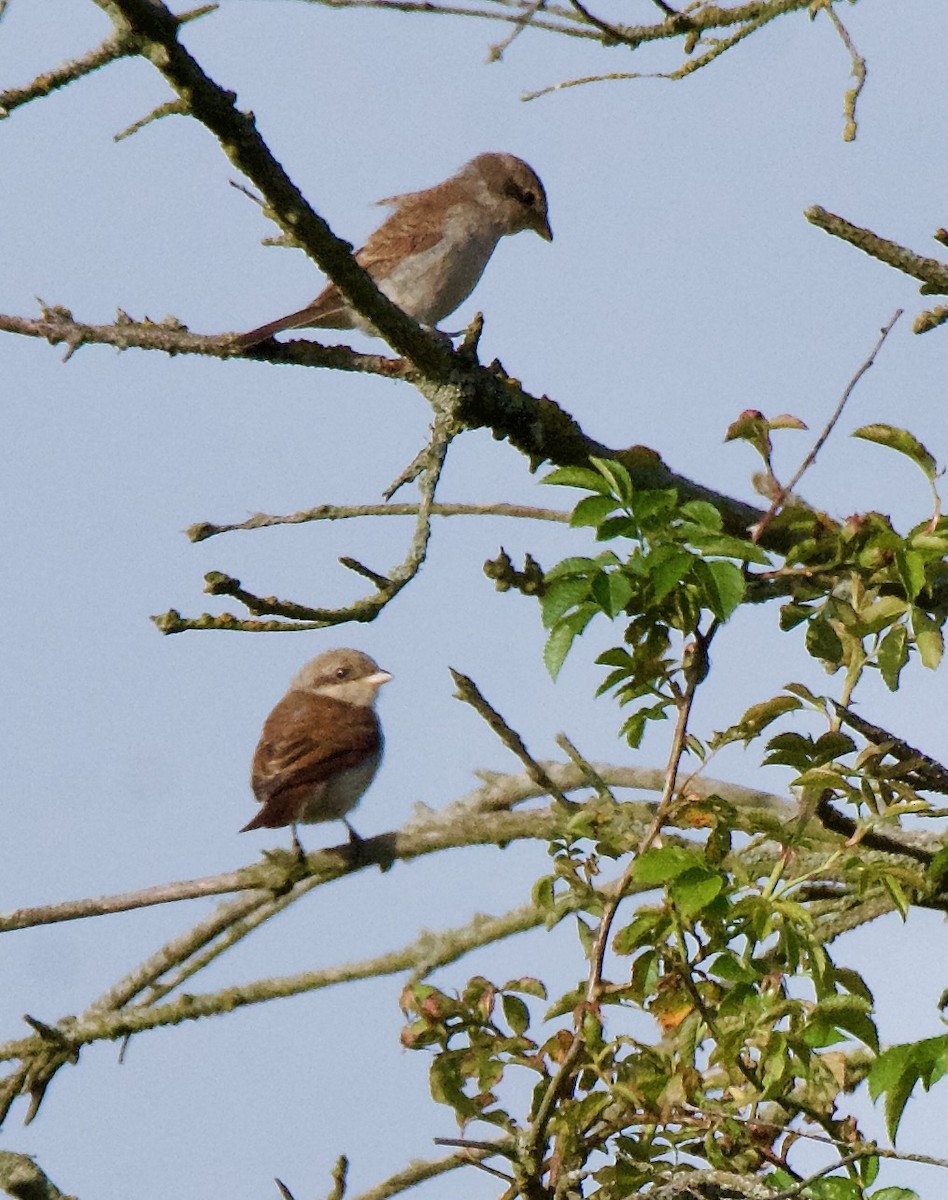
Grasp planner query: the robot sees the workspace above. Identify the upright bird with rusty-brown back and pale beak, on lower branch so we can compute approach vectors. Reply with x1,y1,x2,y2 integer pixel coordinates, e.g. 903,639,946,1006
240,649,392,857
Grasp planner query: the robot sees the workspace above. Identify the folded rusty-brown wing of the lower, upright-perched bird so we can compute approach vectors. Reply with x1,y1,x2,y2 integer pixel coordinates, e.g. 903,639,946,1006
246,691,382,829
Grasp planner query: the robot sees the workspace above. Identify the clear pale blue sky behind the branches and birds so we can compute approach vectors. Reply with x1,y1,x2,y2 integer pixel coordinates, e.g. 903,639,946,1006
0,0,948,1200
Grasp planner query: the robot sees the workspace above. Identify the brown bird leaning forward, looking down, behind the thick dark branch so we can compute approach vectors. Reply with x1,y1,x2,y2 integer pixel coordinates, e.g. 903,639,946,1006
236,154,553,349
